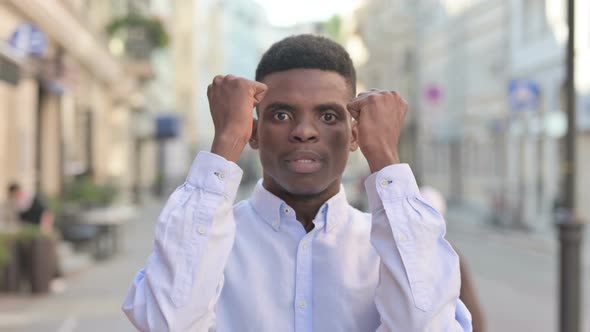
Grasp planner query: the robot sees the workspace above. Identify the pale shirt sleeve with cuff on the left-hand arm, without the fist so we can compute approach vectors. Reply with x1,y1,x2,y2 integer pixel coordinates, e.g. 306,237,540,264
123,152,242,332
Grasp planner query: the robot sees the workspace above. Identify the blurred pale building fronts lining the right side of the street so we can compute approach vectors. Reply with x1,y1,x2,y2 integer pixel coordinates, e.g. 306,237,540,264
358,0,590,231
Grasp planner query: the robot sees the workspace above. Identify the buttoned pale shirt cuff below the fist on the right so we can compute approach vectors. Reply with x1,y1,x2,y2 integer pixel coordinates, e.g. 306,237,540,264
365,164,420,211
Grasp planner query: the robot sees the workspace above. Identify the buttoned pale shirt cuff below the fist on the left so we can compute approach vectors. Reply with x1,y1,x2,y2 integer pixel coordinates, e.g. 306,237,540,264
186,151,244,201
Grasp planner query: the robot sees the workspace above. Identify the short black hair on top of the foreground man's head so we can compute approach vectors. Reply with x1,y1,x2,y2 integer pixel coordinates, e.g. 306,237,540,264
256,34,356,95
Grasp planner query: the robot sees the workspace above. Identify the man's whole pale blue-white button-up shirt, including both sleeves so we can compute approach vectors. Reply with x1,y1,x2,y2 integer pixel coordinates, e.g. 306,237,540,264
123,152,471,332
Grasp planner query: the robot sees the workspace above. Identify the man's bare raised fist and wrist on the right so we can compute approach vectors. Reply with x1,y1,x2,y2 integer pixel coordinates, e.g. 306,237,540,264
347,89,408,173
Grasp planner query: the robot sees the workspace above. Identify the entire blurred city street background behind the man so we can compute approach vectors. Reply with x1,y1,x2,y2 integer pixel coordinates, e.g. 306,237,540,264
0,0,590,332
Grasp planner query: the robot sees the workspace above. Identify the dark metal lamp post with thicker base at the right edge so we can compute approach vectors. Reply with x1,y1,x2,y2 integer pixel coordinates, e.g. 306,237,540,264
555,0,583,332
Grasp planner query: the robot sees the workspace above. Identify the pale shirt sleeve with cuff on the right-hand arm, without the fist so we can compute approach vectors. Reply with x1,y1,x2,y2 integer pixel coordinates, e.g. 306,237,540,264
365,164,471,332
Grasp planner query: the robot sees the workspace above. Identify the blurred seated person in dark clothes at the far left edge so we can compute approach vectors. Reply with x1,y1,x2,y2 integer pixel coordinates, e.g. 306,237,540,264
8,183,53,234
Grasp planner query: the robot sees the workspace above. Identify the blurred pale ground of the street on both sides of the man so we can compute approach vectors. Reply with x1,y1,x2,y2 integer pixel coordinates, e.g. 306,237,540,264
0,195,590,332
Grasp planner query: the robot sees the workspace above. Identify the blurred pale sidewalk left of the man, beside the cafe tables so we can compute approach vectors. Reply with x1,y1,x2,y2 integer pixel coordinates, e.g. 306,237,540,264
0,200,164,332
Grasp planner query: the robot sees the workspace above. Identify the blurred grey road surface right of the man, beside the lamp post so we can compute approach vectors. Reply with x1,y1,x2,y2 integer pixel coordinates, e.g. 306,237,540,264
447,207,590,332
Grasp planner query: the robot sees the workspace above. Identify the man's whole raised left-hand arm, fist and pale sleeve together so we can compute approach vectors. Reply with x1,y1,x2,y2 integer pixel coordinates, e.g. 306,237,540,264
123,75,266,332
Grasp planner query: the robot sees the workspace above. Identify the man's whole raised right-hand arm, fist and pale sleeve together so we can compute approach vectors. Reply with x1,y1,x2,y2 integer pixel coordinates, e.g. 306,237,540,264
347,90,471,332
